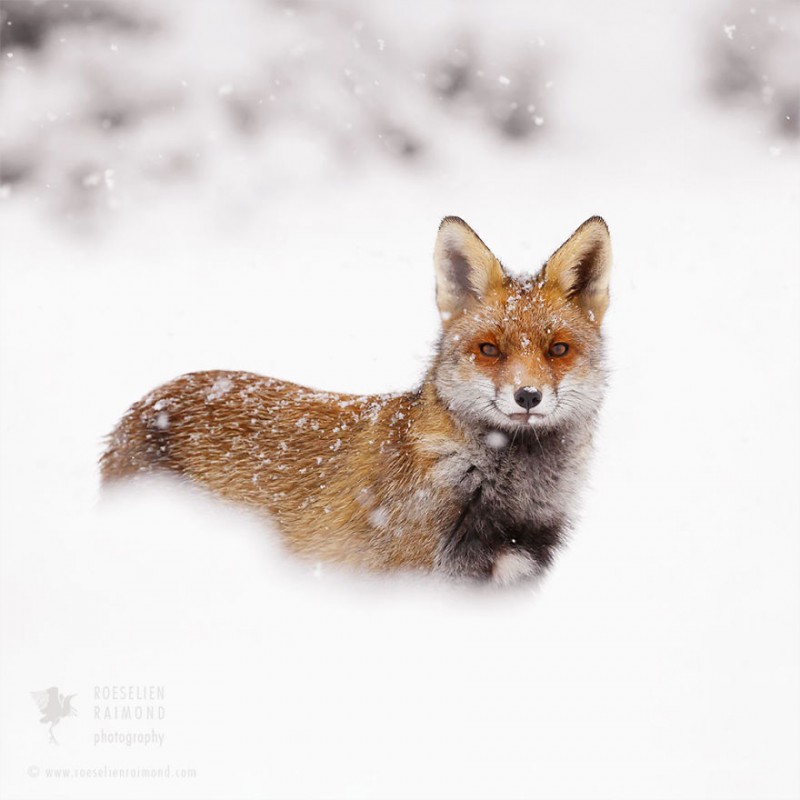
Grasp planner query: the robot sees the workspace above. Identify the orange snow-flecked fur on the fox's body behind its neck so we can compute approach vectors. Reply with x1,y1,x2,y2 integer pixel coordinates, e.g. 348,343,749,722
102,371,457,569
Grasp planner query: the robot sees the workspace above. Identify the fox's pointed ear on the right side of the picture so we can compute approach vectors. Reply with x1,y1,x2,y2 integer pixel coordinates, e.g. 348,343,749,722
544,217,611,324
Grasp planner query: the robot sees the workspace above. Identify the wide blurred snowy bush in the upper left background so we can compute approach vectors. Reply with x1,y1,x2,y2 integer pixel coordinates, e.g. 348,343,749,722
0,0,545,212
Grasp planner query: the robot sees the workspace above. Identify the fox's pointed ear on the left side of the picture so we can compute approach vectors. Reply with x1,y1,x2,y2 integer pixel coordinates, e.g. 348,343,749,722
433,217,505,321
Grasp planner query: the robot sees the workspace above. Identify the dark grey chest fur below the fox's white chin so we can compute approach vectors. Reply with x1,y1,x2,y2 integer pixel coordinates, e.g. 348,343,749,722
439,429,590,580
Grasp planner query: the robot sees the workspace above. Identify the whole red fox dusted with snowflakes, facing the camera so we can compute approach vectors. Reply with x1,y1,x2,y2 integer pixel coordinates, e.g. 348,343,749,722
101,217,611,585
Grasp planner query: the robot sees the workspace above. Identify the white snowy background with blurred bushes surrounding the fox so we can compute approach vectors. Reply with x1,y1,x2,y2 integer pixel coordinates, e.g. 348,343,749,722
0,0,800,800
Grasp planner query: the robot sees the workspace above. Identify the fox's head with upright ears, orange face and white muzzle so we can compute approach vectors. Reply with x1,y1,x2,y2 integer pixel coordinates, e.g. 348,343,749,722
434,217,611,432
